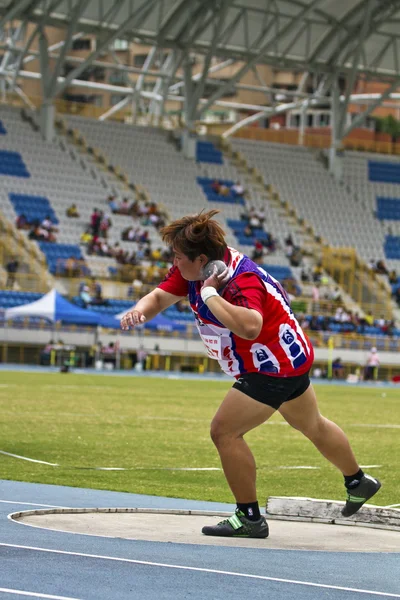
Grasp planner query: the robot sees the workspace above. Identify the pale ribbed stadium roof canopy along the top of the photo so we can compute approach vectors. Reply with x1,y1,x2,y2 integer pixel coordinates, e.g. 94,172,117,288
0,0,400,78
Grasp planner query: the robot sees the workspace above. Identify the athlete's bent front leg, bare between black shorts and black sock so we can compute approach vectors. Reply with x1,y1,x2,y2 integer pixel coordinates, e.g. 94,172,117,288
211,388,275,504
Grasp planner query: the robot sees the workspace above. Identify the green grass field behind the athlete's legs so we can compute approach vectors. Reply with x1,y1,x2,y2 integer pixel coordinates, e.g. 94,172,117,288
0,372,400,506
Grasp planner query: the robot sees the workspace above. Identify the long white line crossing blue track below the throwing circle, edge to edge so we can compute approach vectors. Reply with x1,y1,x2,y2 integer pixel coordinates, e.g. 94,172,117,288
0,542,400,598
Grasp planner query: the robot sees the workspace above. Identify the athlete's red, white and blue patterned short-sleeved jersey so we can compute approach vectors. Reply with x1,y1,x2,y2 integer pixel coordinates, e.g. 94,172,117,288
159,248,314,378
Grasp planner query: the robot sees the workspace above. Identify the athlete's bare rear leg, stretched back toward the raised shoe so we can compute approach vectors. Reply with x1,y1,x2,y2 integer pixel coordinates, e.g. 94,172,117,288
279,385,360,475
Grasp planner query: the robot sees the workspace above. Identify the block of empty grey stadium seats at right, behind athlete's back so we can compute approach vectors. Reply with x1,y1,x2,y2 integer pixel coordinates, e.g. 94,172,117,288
232,139,396,268
